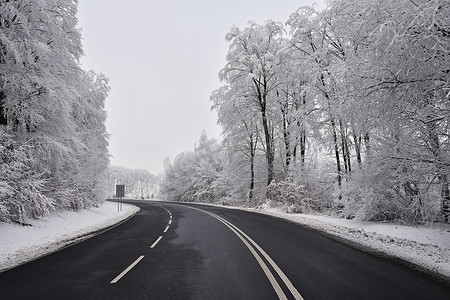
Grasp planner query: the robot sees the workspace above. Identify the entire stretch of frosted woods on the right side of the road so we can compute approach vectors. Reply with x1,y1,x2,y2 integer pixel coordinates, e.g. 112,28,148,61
162,0,450,223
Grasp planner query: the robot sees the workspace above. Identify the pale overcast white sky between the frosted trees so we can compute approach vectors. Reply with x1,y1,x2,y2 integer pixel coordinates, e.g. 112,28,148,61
78,0,324,174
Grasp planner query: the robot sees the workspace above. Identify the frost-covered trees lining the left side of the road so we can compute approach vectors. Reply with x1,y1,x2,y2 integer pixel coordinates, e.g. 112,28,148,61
0,0,109,224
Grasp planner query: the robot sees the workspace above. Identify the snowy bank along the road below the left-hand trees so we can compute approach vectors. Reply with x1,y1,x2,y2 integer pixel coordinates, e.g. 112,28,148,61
0,202,139,272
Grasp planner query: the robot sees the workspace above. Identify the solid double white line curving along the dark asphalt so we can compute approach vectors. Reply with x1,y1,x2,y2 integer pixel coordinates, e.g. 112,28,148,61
190,206,303,300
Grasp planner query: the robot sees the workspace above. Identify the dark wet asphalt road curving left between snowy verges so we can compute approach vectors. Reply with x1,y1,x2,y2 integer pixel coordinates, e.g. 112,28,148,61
0,201,450,300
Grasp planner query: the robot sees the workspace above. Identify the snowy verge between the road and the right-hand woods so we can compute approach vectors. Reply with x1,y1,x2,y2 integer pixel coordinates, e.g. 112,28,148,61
245,205,450,280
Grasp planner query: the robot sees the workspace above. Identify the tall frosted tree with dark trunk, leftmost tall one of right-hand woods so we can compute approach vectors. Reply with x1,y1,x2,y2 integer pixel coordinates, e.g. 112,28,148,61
220,21,284,185
